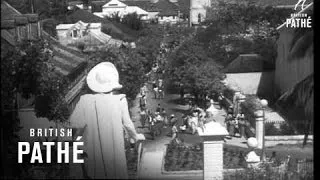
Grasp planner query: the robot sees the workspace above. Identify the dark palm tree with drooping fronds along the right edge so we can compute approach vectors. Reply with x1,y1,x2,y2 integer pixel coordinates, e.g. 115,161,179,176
278,7,314,146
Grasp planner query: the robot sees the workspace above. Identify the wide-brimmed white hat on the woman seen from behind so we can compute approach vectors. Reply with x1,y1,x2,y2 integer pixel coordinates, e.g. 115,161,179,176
87,62,122,93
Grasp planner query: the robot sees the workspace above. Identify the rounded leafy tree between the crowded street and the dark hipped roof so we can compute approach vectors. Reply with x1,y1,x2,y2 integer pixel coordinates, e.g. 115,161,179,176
167,41,224,98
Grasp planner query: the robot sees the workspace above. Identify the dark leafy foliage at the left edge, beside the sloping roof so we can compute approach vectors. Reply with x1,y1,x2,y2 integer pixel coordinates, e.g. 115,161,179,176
1,40,68,121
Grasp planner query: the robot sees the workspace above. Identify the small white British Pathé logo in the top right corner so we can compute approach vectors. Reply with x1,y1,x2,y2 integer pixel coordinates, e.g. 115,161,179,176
286,0,311,28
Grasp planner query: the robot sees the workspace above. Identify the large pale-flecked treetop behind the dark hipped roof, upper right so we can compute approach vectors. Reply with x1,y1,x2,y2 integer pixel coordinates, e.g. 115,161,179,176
202,2,292,68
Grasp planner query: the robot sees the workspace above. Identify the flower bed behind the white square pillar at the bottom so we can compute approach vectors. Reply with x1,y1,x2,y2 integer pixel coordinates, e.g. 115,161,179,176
164,144,247,171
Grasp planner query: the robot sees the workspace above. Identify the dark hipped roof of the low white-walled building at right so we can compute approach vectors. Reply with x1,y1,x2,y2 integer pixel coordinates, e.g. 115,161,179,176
223,54,269,73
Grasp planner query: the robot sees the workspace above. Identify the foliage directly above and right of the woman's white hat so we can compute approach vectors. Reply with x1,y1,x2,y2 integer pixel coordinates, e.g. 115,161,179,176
90,48,147,101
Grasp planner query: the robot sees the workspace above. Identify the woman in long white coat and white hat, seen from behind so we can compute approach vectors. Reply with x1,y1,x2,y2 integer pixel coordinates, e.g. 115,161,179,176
70,62,145,179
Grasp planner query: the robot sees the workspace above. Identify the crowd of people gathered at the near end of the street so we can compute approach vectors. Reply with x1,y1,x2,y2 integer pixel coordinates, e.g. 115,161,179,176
140,76,254,142
